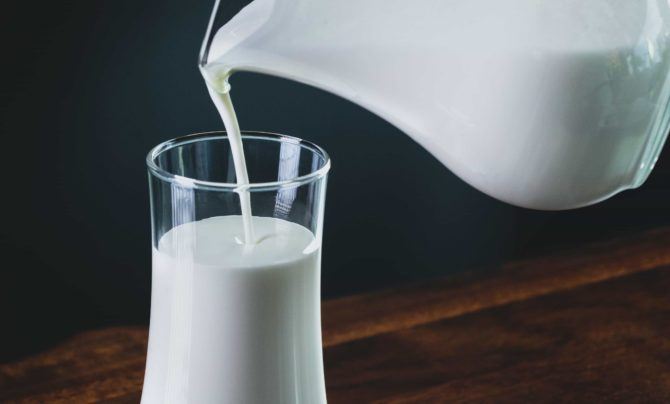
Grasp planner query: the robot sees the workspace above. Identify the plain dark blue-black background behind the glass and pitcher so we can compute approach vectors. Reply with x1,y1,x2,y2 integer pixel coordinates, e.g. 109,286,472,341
0,0,670,360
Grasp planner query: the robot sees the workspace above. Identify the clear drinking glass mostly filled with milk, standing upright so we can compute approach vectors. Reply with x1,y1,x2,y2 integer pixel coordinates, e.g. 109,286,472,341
142,132,330,403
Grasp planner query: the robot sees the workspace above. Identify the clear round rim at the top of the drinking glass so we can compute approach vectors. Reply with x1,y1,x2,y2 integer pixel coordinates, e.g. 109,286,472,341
146,130,330,192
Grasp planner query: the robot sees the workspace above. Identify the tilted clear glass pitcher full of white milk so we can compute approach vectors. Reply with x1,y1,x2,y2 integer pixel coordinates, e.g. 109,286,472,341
204,0,670,209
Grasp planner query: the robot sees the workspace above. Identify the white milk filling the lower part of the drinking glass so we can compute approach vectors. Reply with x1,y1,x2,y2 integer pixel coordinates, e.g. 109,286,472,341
142,216,326,404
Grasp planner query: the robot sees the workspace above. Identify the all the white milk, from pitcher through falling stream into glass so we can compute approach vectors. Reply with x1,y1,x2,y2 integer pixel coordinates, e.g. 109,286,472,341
142,0,670,403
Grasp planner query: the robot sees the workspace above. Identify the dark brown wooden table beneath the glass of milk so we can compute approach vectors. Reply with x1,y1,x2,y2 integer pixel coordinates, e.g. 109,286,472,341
0,229,670,403
